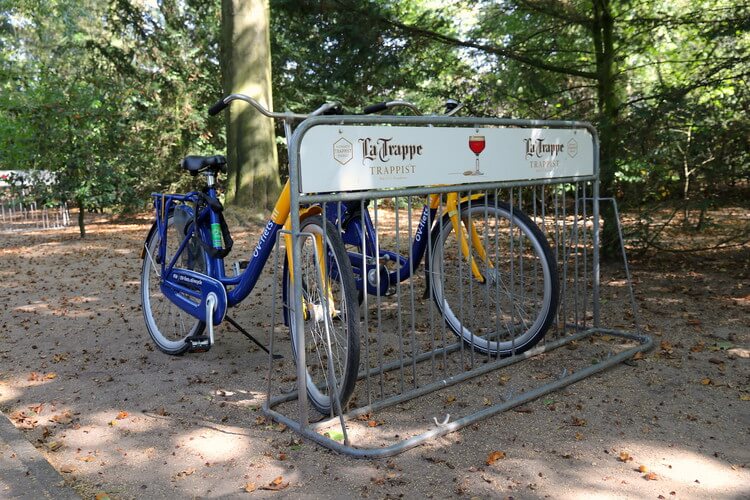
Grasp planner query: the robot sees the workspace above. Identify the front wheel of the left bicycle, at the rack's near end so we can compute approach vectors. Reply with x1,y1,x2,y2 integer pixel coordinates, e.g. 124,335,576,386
284,216,359,415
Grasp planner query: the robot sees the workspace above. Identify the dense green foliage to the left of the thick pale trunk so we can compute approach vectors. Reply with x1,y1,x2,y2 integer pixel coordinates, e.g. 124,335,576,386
0,0,223,233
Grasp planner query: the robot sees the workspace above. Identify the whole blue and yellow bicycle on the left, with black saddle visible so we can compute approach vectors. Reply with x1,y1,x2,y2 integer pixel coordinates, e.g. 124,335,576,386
141,94,359,415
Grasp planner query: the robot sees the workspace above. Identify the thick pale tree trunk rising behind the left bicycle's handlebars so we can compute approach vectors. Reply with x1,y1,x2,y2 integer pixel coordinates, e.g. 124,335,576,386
221,0,281,209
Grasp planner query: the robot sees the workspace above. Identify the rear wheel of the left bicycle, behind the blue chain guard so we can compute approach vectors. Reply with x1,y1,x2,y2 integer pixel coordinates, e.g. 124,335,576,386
141,215,206,355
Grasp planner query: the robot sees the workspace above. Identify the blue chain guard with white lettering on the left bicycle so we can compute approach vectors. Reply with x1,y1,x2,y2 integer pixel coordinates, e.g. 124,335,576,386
160,269,227,325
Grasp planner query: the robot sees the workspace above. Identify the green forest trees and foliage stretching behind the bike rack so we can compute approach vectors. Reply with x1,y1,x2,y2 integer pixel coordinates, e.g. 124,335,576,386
0,0,750,248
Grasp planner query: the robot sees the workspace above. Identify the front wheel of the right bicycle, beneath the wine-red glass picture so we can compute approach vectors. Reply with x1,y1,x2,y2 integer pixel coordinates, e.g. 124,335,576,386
430,199,559,356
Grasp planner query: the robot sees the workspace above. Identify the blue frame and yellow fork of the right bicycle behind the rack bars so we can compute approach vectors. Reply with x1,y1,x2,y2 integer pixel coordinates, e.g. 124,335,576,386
326,192,494,295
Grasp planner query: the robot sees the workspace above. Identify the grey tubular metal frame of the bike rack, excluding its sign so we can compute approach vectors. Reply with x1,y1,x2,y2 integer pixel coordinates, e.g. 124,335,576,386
263,116,653,458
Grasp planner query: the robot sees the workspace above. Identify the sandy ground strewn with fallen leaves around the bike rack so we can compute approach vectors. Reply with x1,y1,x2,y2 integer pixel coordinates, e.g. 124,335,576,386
0,210,750,498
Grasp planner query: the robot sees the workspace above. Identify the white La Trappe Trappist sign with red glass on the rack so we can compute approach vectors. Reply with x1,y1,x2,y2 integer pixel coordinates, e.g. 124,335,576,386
300,125,594,193
